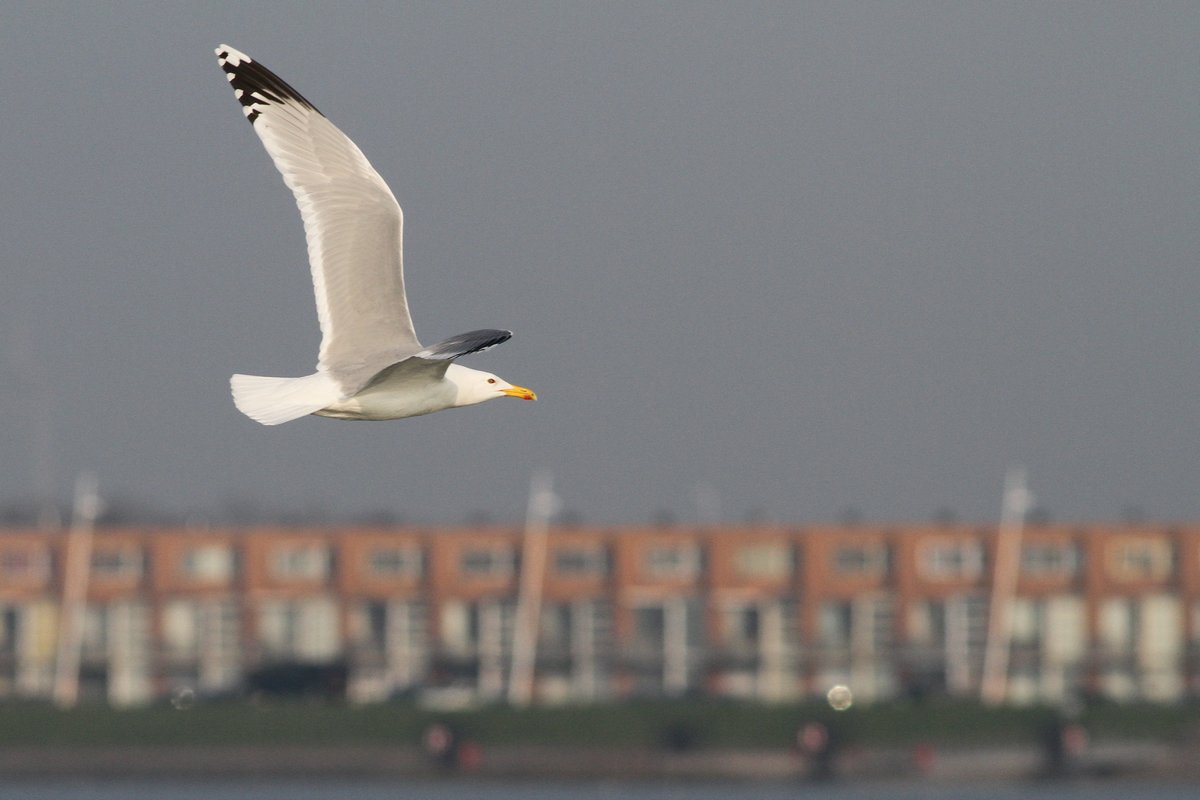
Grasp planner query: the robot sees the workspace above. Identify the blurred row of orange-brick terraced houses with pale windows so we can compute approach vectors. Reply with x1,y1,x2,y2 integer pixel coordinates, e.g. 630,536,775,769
0,523,1200,705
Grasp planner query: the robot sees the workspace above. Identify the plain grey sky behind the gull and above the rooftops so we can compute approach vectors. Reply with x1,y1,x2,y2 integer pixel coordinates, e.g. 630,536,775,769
0,1,1200,522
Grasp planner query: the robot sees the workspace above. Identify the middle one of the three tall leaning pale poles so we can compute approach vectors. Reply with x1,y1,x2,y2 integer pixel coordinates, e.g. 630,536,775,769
509,473,558,706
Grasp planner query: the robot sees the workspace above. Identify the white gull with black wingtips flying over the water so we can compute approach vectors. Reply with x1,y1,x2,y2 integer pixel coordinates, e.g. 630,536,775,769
216,44,535,425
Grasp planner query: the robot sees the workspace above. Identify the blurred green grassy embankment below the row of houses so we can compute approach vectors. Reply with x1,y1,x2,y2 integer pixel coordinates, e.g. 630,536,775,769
0,700,1200,750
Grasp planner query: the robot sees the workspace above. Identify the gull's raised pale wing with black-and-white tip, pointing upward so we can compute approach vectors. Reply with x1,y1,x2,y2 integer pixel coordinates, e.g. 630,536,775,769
216,44,421,395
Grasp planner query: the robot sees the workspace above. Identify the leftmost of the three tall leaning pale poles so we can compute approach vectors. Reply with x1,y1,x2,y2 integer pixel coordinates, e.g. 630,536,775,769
54,473,101,708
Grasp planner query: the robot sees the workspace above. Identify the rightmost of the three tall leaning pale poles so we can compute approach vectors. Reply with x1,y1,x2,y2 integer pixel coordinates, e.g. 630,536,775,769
979,467,1033,705
